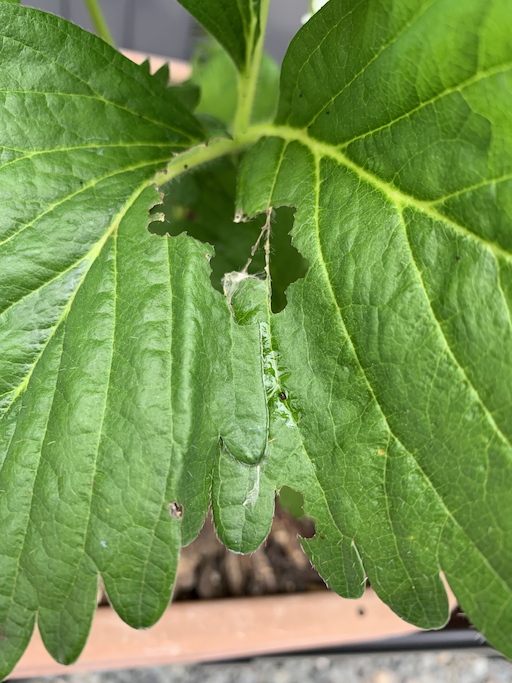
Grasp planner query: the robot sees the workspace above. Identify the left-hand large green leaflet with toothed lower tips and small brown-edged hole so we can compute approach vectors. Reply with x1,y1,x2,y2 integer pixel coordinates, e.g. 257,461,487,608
0,3,231,675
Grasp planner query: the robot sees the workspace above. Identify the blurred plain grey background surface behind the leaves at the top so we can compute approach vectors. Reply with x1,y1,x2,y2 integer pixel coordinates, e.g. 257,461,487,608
22,0,309,60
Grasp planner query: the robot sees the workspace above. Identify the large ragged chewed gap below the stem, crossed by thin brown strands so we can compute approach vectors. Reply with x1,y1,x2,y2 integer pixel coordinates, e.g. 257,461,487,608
149,159,308,313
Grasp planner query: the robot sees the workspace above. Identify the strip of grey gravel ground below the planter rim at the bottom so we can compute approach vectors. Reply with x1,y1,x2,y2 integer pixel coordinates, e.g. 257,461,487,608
15,651,512,683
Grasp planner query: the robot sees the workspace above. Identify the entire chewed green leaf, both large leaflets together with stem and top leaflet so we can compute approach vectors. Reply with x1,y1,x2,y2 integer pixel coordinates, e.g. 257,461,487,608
0,0,512,674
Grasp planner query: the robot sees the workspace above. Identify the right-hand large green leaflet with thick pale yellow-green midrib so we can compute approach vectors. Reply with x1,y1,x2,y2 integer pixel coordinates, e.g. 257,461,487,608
236,0,512,655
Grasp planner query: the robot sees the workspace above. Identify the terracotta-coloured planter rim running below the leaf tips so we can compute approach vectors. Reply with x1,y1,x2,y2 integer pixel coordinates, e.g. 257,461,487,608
10,590,453,678
